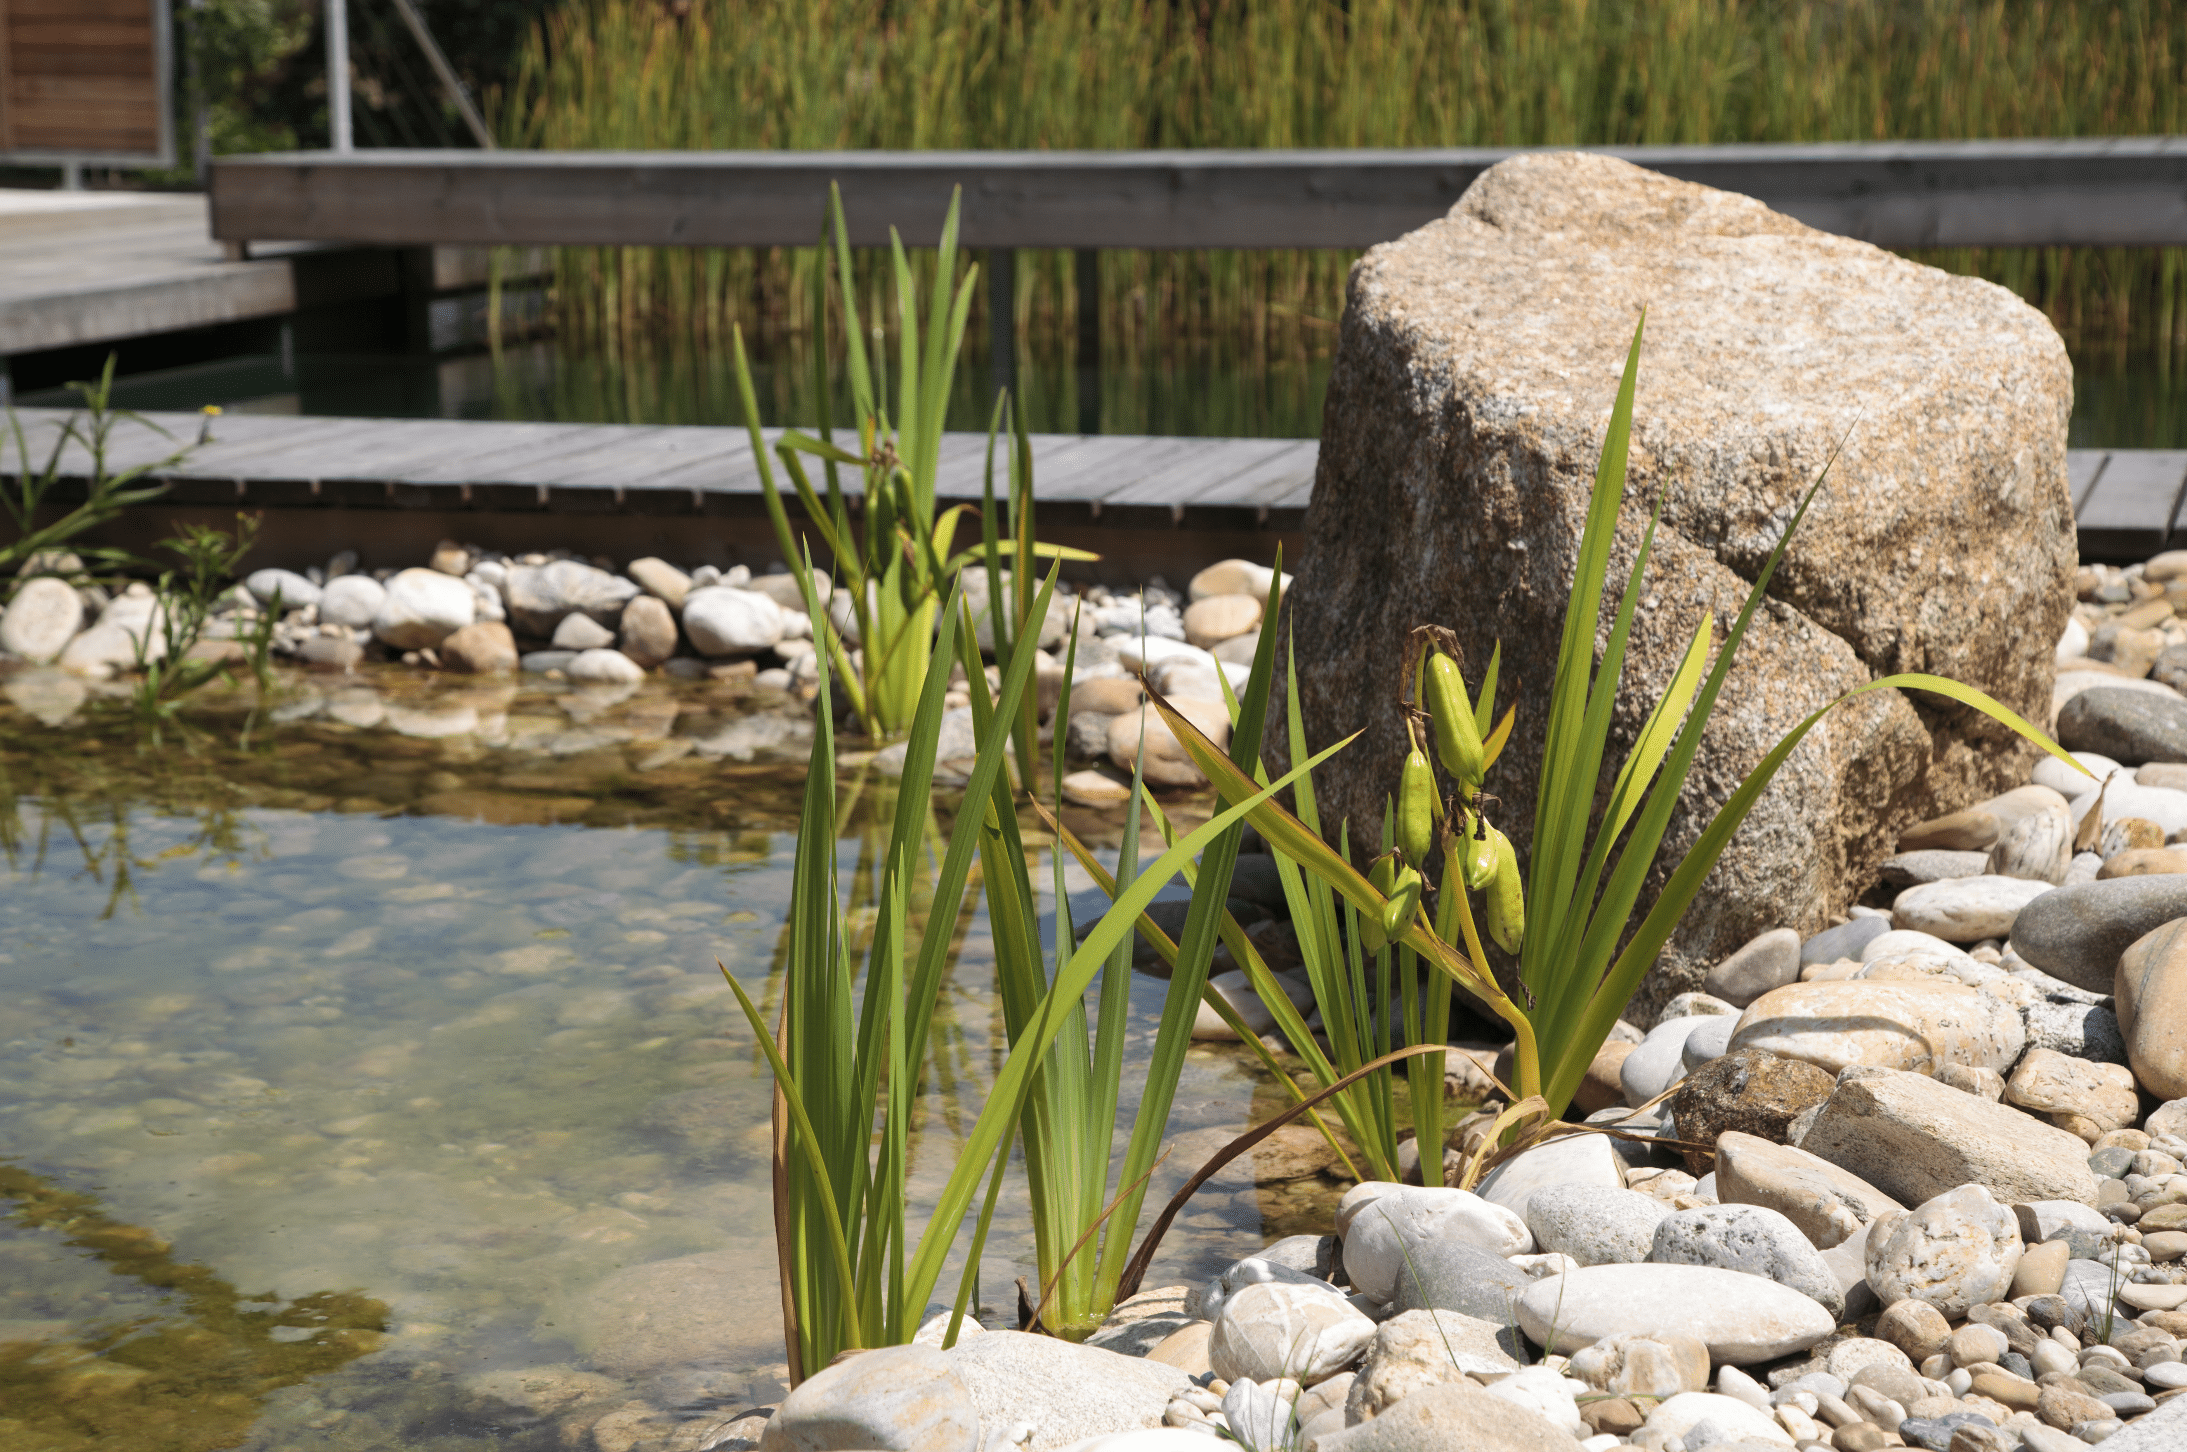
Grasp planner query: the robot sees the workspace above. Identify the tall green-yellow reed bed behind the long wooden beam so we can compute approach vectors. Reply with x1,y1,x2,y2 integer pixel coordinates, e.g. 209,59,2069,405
496,0,2187,407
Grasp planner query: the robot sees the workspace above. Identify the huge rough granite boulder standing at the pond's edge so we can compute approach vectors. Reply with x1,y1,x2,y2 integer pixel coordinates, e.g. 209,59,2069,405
1286,153,2075,1004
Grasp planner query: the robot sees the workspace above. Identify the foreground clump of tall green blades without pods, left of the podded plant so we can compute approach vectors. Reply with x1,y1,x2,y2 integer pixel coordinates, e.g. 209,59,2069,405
730,408,1325,1378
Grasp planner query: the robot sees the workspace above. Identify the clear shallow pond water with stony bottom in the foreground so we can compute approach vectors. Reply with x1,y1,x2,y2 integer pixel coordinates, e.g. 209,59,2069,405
0,667,1341,1452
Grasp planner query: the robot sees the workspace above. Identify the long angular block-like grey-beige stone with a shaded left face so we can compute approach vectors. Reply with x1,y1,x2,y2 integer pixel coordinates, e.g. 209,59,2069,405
1800,1069,2095,1205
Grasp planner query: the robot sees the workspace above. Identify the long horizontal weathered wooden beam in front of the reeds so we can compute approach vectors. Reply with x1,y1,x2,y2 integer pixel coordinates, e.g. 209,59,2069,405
212,138,2187,249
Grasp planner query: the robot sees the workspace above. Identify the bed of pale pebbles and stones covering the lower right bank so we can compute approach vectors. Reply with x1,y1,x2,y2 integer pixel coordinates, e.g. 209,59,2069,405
746,553,2187,1452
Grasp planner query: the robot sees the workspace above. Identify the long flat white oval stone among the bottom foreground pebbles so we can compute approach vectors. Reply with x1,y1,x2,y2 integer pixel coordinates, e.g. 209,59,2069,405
1518,1264,1837,1367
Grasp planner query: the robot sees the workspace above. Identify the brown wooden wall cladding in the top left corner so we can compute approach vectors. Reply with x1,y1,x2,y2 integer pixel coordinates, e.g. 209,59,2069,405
0,0,173,164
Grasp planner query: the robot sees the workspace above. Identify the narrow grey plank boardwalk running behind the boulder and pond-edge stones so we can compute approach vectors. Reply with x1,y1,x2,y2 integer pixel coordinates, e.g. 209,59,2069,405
0,409,2187,560
